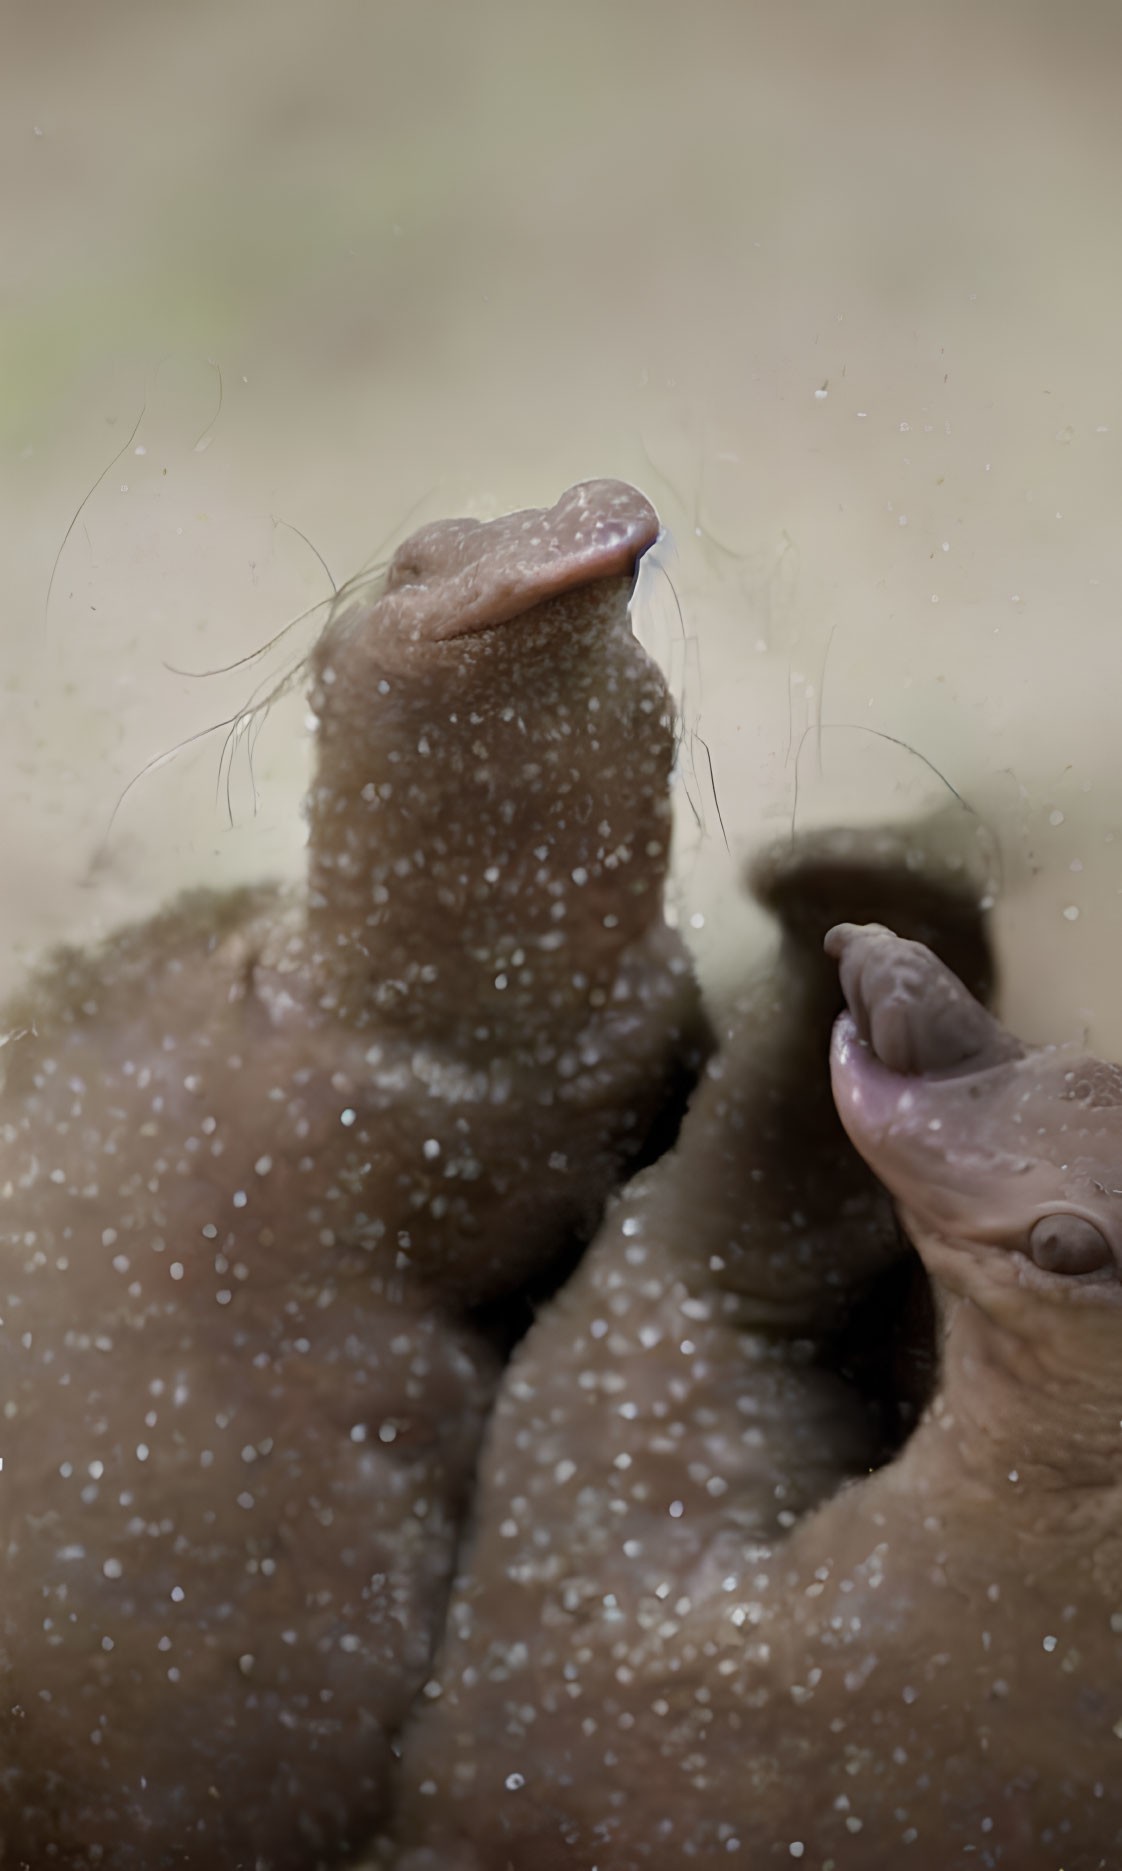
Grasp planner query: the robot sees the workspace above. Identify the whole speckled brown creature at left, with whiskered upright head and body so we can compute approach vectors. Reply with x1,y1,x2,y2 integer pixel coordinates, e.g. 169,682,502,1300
0,481,701,1871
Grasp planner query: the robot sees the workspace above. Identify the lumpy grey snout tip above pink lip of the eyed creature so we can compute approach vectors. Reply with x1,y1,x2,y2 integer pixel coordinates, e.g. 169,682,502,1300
825,922,1025,1141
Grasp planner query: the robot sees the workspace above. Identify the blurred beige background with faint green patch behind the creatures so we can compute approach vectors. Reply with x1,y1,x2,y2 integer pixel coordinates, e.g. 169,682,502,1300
0,0,1122,1053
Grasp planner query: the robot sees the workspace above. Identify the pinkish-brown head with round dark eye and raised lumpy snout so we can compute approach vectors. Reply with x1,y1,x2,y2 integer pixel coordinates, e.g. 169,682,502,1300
827,922,1122,1364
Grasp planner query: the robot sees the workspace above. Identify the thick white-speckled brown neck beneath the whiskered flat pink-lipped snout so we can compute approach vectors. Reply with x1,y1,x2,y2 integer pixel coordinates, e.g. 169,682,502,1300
309,632,673,1050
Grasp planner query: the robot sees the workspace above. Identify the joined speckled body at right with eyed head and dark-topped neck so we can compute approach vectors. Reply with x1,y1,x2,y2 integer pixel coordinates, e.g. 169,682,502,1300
389,812,1122,1871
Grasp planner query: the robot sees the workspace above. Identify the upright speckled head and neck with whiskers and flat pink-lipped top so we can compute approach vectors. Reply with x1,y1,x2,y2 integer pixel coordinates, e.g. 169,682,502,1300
307,481,675,1038
